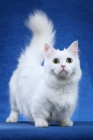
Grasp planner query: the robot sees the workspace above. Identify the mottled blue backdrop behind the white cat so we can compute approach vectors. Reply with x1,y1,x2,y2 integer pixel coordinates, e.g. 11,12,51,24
0,0,93,121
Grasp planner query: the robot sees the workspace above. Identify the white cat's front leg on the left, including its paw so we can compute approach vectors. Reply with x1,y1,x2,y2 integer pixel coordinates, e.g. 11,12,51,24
31,96,49,127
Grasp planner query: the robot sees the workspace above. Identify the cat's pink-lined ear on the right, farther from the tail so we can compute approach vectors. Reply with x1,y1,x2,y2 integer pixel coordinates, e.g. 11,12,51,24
68,41,79,56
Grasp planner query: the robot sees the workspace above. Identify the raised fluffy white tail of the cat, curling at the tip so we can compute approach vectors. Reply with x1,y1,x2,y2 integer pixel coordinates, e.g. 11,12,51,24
18,11,55,67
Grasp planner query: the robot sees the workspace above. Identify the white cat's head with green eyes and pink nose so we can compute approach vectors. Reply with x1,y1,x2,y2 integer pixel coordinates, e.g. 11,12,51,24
44,41,81,79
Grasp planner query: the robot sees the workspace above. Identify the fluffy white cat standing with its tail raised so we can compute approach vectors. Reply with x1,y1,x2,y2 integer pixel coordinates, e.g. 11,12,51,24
6,11,81,127
